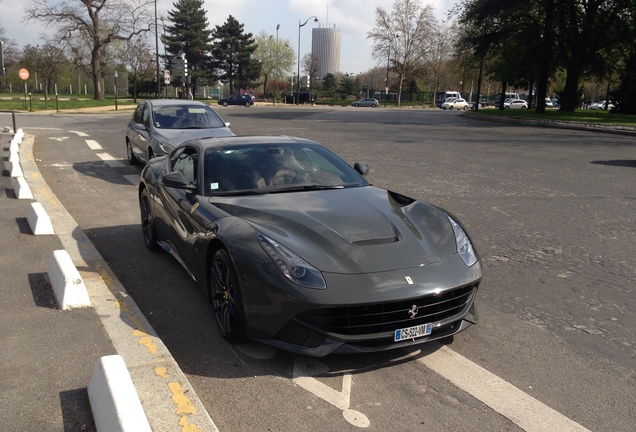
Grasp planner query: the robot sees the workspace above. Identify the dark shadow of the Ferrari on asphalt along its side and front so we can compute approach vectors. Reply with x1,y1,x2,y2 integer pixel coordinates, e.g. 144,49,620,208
85,225,452,379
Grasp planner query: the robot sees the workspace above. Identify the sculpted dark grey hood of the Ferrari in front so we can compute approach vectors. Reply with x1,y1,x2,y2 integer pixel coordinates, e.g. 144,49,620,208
211,186,457,274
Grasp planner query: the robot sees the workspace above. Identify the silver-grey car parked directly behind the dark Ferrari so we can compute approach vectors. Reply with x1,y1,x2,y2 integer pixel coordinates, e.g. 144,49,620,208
126,99,234,165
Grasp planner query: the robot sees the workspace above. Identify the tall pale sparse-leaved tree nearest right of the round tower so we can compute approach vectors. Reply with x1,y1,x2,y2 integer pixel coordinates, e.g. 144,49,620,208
367,0,436,106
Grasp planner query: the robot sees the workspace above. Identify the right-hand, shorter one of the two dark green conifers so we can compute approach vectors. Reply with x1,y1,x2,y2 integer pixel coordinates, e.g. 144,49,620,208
212,15,261,94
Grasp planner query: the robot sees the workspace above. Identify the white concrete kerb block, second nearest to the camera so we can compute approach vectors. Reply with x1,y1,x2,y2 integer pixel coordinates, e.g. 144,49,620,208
48,250,91,309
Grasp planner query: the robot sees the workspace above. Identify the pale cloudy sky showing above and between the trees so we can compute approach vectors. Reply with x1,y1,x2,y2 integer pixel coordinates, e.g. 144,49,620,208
0,0,459,74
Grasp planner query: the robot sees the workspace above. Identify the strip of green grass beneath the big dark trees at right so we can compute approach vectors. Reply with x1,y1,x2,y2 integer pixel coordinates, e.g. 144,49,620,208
476,108,636,127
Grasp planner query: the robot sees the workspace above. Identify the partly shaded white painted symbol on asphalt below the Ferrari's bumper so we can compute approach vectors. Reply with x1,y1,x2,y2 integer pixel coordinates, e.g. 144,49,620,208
292,355,371,428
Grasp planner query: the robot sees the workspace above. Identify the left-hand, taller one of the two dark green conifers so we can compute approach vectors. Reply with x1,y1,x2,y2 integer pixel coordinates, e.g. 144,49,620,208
161,0,212,93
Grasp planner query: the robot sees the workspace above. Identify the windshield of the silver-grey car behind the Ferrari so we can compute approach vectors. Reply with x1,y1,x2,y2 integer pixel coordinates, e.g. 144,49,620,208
152,104,225,129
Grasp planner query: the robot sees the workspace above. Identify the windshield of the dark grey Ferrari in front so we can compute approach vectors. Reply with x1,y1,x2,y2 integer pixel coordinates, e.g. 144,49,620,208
203,143,369,196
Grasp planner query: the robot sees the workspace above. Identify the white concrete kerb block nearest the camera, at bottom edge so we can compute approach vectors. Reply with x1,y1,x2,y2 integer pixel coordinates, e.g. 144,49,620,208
88,355,151,432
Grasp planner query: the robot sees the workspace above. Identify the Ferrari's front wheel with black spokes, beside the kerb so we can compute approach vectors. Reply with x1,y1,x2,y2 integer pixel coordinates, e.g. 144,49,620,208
210,249,245,342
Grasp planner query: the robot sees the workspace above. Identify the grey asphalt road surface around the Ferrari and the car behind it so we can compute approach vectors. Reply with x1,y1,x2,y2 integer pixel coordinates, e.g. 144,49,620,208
13,107,636,431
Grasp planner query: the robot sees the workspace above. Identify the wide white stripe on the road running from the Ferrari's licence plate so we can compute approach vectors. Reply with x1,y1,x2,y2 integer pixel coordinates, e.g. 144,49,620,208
413,342,589,432
